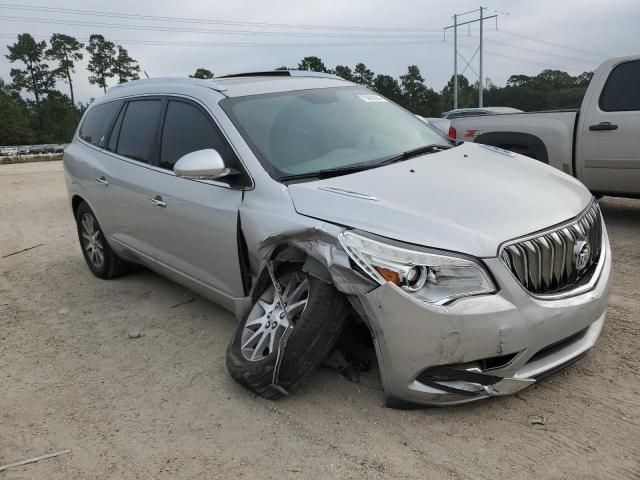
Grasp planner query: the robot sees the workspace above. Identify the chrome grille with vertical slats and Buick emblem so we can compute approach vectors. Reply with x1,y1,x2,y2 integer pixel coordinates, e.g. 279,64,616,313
500,200,602,295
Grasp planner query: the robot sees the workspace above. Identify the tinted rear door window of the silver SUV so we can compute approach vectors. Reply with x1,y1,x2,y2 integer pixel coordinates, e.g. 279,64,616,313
116,100,162,163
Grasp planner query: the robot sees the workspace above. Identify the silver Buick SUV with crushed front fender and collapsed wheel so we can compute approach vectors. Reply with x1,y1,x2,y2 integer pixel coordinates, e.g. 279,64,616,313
64,71,611,407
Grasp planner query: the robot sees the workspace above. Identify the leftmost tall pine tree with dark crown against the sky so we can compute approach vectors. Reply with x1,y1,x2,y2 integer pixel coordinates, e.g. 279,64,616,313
5,33,55,113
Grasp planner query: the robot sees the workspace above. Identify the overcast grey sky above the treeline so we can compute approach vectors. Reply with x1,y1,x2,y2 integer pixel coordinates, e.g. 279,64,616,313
0,0,640,101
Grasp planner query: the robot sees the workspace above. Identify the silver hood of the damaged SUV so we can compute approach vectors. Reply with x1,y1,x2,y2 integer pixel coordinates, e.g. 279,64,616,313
289,143,591,257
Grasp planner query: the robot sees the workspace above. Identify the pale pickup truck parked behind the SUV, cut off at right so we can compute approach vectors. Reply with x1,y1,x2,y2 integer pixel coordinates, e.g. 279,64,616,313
449,55,640,197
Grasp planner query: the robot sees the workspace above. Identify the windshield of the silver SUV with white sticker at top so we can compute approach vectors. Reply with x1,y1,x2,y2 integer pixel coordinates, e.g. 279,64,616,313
220,87,451,179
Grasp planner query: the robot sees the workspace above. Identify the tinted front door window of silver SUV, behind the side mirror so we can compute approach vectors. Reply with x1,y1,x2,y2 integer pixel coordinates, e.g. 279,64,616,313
160,101,237,170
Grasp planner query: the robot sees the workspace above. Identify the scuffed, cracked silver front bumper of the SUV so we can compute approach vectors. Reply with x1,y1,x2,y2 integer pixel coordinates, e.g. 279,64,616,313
359,244,611,405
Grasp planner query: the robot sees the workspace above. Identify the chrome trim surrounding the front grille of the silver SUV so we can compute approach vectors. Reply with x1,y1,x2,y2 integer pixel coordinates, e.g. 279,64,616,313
497,198,608,300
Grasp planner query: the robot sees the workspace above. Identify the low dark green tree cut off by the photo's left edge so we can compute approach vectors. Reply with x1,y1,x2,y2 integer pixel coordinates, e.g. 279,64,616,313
0,78,34,145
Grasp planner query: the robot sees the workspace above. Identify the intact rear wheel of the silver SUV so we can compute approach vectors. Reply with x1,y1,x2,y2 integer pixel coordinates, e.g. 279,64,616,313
76,202,131,279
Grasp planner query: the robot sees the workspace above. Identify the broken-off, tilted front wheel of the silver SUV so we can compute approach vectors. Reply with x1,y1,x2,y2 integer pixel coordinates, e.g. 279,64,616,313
227,270,349,400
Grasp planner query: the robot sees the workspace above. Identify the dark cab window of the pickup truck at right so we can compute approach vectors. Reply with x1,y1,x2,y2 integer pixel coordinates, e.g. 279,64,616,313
600,61,640,112
